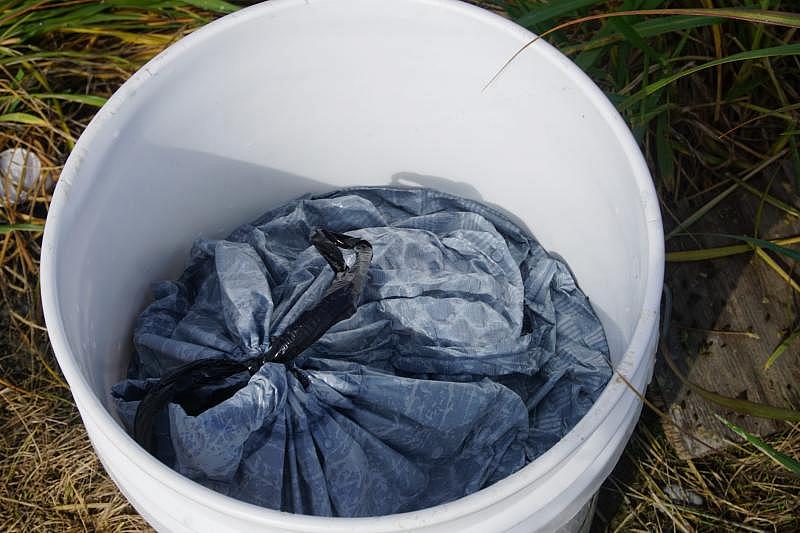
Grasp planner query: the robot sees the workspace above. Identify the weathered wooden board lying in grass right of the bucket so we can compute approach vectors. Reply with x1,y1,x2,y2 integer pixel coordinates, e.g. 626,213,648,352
654,177,800,458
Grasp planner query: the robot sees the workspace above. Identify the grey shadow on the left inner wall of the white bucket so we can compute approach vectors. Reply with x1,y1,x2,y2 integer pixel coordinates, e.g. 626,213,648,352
78,144,344,404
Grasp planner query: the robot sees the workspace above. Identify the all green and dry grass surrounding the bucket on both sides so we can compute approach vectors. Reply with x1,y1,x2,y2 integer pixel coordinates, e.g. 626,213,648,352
0,0,800,531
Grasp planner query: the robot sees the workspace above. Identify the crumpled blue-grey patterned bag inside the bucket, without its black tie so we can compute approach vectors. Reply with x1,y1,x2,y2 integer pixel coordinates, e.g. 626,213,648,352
112,188,611,517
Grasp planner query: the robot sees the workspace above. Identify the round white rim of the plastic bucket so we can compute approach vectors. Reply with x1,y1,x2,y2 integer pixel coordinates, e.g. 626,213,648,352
41,0,664,532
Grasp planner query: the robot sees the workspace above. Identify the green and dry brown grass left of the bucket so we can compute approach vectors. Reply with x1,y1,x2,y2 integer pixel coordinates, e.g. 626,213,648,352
0,0,225,532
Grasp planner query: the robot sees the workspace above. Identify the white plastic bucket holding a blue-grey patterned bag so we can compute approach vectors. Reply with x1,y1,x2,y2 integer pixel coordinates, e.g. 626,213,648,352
42,0,664,533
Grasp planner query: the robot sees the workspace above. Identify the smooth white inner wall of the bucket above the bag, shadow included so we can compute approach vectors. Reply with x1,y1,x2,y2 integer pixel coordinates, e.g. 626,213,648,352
51,0,648,412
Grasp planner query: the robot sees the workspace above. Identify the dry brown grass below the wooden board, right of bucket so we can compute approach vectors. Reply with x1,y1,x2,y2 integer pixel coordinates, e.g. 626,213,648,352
595,416,800,532
